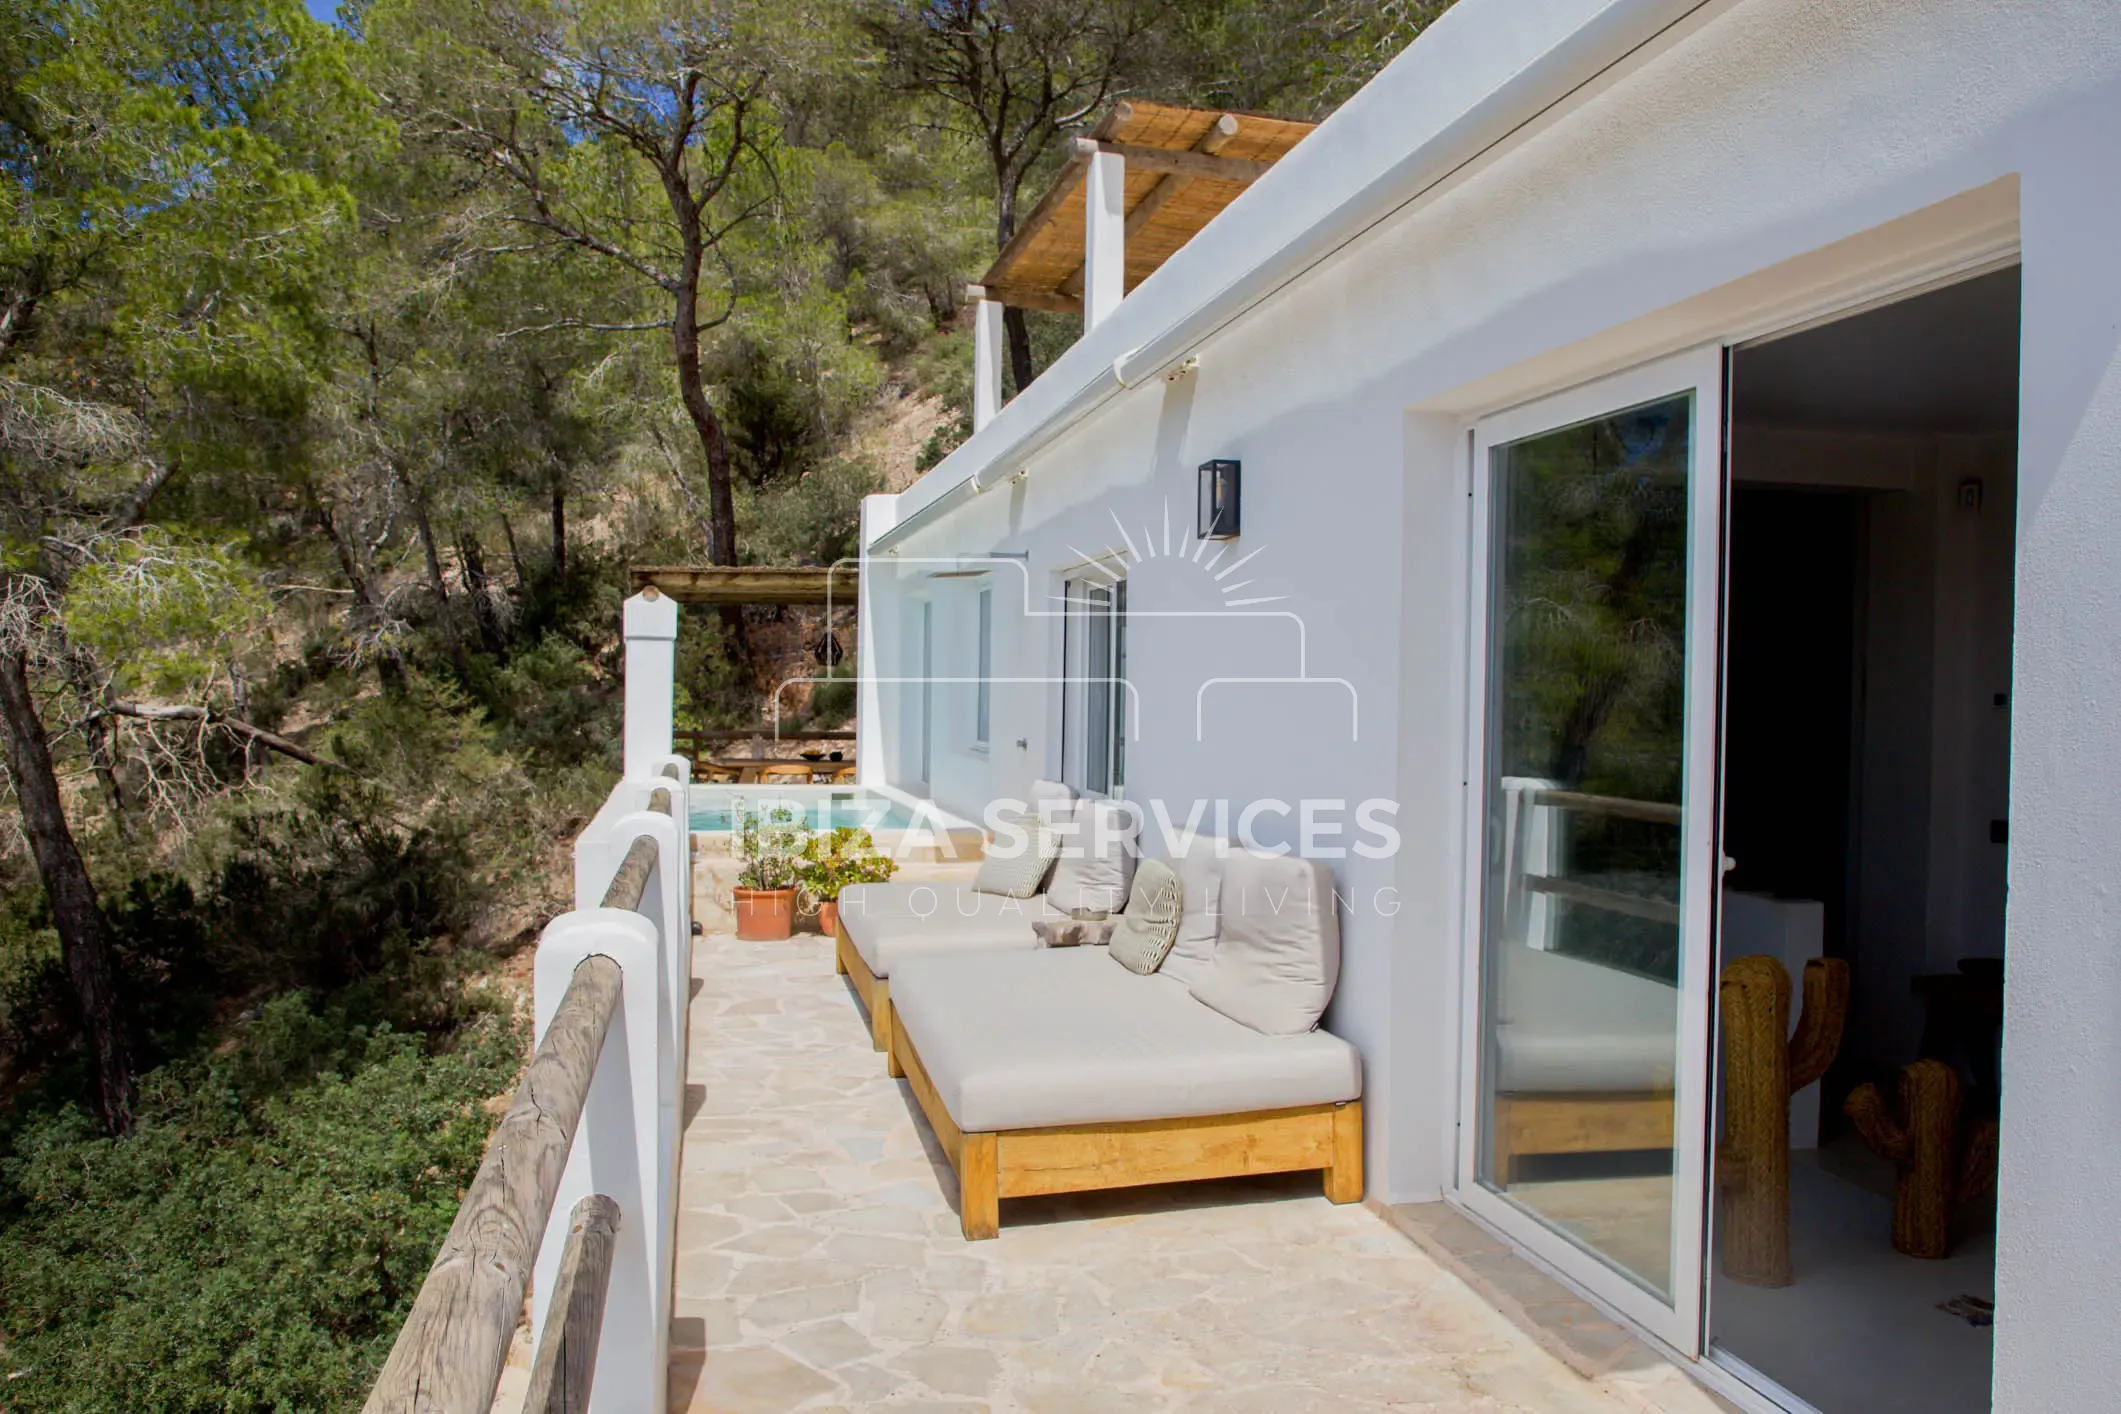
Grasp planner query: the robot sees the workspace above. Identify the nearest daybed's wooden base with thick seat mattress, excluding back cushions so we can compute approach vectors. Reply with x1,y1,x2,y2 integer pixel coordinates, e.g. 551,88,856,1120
878,948,1362,1238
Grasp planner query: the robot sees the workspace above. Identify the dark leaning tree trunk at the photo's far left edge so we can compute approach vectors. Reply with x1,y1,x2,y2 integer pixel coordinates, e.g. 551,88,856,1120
0,649,134,1134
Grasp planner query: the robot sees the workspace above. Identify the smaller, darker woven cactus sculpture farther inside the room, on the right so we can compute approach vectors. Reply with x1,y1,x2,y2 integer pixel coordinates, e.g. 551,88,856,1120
1841,1060,1996,1257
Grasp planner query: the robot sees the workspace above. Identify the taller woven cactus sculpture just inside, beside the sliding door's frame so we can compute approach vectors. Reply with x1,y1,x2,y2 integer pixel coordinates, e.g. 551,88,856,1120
1716,954,1850,1287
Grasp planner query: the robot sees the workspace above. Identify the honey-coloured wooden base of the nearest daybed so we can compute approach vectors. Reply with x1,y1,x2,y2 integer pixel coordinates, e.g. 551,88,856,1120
890,1017,1362,1242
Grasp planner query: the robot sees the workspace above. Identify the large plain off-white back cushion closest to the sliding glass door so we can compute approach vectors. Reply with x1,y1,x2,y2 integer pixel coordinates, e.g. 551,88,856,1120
1192,854,1340,1037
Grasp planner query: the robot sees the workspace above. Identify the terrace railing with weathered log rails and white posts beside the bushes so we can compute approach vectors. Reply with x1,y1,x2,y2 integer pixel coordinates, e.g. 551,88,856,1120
365,759,691,1414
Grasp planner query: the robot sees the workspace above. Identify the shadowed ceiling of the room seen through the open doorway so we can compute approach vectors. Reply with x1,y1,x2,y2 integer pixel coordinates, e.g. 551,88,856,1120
1731,267,2017,432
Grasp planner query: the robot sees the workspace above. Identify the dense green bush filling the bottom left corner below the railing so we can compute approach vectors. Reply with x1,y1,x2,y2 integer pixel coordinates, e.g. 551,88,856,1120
0,996,522,1414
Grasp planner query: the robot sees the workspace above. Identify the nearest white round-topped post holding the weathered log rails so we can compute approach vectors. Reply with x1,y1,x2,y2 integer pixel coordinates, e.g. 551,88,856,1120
530,909,670,1414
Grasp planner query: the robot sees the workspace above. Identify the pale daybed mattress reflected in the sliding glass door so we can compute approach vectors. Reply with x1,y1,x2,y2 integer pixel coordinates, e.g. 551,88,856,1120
1495,943,1680,1094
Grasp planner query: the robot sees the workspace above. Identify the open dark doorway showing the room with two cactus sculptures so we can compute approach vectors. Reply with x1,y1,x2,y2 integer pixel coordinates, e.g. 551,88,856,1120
1707,269,2019,1414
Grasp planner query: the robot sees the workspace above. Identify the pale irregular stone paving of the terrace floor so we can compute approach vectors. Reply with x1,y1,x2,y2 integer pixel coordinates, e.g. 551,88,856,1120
670,935,1718,1414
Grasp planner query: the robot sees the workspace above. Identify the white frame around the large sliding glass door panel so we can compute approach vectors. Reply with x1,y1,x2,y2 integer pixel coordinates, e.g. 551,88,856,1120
1451,343,1729,1355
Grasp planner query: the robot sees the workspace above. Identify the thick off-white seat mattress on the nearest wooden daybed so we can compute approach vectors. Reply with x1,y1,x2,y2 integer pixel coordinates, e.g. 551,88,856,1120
891,948,1362,1132
